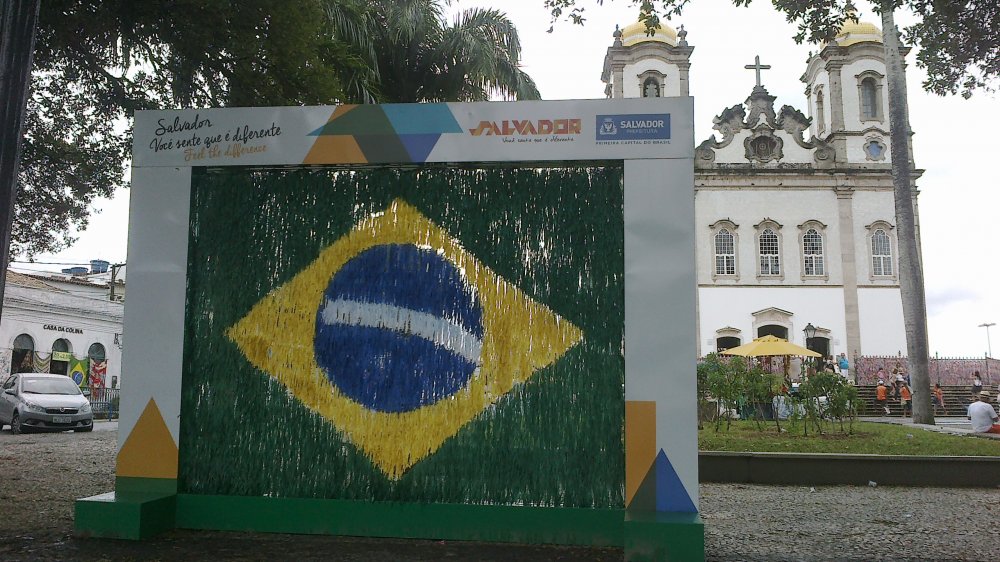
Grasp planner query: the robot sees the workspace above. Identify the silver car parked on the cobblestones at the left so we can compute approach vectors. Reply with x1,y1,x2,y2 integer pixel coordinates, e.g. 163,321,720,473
0,373,94,433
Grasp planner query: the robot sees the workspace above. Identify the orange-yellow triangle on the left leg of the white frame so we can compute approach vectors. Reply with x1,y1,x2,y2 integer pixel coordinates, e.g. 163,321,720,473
115,398,177,478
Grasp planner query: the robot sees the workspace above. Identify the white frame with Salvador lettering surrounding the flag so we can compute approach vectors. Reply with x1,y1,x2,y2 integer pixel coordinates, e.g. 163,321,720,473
118,98,698,520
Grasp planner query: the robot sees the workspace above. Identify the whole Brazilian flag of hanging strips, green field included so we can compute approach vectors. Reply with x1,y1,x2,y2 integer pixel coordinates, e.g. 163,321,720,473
178,164,625,509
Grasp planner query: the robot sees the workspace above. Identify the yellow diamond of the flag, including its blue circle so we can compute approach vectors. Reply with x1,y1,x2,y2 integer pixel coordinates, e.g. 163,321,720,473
227,200,583,479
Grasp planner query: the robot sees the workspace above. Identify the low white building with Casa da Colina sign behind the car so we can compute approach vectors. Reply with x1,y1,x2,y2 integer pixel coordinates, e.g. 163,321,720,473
0,271,124,388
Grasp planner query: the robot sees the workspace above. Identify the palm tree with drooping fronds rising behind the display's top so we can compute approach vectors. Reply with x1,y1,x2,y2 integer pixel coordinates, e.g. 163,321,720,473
358,0,539,103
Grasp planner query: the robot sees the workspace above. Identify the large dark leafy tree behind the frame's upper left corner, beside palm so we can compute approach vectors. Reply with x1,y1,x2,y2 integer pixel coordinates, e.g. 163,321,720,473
11,0,366,256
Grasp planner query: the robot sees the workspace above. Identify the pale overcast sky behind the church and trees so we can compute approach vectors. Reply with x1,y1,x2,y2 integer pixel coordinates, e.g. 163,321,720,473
17,0,1000,356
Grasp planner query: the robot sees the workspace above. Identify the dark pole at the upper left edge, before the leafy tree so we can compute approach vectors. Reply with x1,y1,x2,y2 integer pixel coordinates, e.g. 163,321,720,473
0,0,40,322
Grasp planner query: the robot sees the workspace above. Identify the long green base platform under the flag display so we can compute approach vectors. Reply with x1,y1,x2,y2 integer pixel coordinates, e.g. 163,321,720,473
76,490,705,562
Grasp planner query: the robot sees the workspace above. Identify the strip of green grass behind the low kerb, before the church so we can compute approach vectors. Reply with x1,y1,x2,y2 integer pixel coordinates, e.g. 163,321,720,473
698,421,1000,457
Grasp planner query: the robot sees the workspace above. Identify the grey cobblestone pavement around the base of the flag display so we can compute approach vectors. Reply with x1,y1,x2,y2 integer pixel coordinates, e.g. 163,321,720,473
0,425,1000,562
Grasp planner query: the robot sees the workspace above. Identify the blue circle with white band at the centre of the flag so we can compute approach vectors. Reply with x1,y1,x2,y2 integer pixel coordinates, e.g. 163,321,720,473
314,244,483,412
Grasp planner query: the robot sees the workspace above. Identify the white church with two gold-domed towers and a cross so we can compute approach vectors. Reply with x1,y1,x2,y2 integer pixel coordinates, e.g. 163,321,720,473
602,18,920,357
